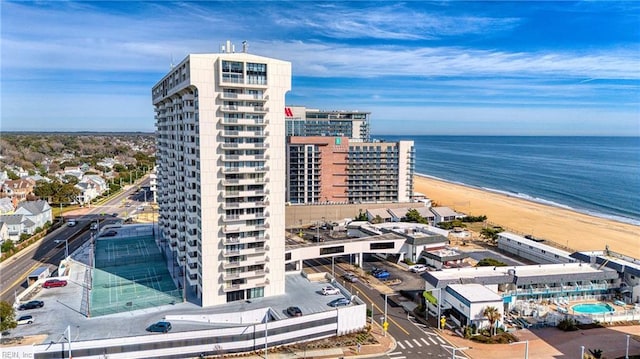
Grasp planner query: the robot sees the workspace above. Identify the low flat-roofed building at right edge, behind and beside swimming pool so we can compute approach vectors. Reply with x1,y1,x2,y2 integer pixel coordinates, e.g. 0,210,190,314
571,249,640,304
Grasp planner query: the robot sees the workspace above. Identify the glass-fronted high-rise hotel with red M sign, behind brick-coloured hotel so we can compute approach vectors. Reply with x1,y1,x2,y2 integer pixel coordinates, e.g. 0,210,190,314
285,106,371,142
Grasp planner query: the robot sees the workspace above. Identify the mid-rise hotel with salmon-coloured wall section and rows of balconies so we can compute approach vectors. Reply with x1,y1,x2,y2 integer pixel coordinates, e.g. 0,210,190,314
287,136,415,204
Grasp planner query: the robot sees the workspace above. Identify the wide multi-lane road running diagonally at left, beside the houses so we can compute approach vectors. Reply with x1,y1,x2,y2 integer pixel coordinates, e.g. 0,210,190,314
0,178,149,303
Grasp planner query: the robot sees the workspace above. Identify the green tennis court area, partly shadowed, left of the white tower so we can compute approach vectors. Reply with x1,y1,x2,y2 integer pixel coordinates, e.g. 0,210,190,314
89,236,182,317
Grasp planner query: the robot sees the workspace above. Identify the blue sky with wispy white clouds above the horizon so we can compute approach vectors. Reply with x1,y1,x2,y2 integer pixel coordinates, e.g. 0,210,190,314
0,1,640,136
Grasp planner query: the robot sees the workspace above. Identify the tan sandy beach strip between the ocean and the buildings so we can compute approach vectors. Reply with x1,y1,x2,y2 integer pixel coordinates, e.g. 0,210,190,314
414,176,640,258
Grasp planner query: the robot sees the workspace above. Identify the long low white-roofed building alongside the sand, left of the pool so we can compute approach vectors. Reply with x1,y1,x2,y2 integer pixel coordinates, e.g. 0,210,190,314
498,232,577,264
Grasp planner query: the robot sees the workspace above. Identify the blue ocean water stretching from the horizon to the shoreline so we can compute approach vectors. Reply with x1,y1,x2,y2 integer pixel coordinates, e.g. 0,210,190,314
380,136,640,225
